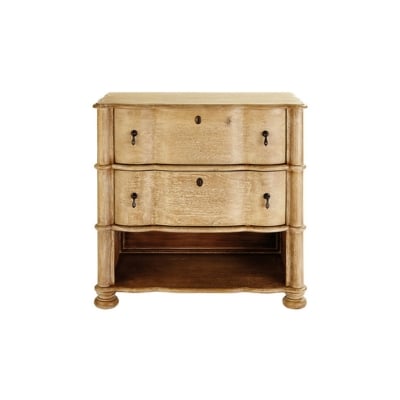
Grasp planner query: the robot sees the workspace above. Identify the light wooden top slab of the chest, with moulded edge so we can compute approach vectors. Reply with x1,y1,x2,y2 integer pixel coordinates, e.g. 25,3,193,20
94,92,305,108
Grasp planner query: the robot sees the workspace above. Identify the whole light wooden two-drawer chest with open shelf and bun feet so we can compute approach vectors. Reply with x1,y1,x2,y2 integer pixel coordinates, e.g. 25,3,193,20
95,93,306,308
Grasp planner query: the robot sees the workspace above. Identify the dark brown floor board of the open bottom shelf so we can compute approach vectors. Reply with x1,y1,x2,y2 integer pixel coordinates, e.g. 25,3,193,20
113,253,285,292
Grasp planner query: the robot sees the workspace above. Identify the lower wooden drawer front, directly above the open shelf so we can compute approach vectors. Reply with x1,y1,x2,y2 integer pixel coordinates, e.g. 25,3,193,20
115,171,286,226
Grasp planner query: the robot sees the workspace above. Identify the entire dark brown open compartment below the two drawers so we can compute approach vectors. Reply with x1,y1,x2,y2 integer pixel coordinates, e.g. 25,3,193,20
114,232,285,292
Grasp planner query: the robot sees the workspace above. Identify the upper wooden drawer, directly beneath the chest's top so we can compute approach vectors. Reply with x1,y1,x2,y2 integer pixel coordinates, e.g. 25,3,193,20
114,106,286,165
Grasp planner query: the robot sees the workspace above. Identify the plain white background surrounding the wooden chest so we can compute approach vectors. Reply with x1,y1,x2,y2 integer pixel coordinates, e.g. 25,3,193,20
0,0,400,400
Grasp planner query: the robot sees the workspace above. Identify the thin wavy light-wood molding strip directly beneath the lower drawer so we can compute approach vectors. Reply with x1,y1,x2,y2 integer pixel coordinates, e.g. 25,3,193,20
111,225,289,233
